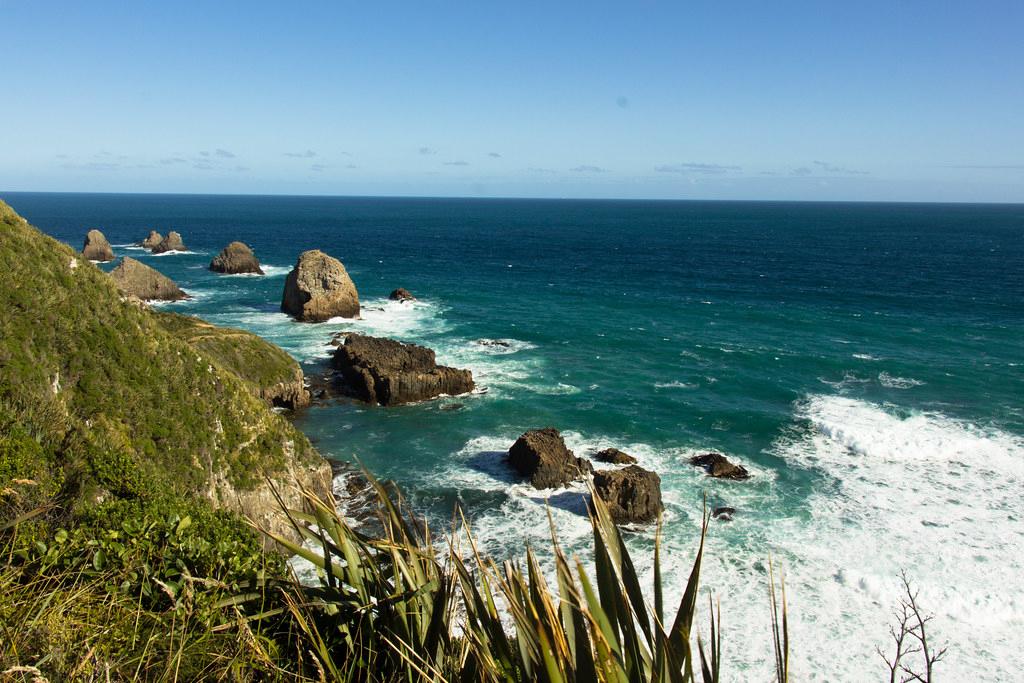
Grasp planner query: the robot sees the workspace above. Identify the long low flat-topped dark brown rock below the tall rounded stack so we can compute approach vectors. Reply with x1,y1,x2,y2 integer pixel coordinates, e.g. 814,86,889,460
333,335,473,405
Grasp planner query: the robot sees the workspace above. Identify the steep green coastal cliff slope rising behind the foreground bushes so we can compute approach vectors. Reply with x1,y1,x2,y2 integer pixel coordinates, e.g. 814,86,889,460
0,197,330,544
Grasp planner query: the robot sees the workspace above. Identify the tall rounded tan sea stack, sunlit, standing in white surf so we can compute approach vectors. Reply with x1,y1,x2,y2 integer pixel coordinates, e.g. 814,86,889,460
281,249,359,323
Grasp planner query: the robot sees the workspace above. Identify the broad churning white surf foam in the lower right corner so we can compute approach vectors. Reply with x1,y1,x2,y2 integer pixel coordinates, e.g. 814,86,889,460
745,396,1024,681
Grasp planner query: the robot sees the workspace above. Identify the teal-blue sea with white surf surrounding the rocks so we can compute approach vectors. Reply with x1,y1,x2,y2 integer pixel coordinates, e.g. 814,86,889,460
3,193,1024,680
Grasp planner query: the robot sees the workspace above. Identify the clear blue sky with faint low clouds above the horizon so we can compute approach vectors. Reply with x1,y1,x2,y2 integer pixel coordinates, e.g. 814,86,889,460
0,0,1024,202
